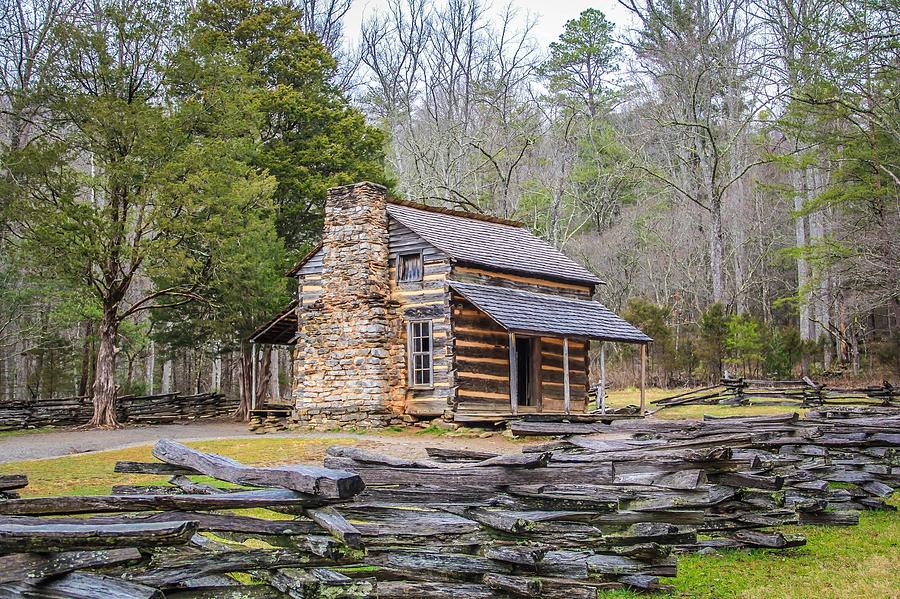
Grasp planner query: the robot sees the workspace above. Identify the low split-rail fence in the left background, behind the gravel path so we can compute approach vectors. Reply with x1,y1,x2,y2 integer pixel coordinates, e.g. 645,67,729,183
0,393,238,430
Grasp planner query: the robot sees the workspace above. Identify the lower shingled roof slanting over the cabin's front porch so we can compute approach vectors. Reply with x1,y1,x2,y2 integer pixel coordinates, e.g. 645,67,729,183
449,281,653,343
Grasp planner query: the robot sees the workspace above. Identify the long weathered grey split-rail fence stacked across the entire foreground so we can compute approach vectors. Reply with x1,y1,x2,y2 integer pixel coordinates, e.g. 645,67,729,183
0,408,900,599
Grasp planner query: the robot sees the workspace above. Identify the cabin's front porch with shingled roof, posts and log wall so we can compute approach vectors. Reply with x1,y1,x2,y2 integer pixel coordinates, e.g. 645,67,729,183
450,281,651,422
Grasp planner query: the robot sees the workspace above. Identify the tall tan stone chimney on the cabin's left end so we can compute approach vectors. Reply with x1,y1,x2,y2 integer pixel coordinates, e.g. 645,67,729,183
294,183,396,428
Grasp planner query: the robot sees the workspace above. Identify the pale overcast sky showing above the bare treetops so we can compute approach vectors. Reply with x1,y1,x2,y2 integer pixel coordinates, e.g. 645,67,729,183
344,0,629,48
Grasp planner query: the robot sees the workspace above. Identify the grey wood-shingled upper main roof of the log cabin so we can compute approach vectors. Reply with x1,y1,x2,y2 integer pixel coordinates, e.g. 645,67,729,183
387,201,602,285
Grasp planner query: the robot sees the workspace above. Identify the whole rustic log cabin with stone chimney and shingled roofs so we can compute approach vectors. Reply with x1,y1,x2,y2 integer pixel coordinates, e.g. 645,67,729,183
250,182,651,428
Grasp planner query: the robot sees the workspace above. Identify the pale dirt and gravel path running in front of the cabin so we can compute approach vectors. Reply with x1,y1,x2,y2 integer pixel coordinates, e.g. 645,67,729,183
0,421,521,464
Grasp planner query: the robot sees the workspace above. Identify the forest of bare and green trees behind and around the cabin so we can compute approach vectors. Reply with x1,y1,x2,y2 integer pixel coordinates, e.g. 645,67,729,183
0,0,900,424
